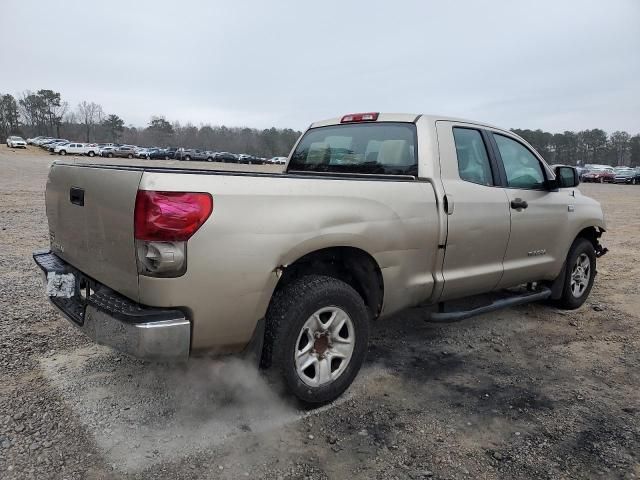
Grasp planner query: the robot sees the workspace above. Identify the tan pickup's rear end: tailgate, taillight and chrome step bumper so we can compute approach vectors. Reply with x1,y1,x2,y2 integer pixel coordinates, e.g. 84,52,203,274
34,163,213,359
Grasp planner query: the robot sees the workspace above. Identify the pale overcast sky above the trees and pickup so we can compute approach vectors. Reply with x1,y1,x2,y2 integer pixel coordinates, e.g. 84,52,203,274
0,0,640,134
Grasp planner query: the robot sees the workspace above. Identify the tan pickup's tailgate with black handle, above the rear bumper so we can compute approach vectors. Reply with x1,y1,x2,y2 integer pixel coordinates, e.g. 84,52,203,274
45,163,142,301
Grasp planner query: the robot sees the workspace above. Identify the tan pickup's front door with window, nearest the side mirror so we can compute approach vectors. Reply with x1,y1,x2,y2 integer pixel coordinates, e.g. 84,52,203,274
490,131,573,287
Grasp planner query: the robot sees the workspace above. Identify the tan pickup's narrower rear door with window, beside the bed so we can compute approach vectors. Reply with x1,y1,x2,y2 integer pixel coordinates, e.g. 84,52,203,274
436,121,510,300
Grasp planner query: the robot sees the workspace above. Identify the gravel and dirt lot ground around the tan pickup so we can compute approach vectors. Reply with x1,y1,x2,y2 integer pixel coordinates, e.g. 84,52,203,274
0,146,640,479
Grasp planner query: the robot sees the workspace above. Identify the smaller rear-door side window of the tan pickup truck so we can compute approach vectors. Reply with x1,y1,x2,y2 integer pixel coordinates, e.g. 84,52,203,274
453,127,493,185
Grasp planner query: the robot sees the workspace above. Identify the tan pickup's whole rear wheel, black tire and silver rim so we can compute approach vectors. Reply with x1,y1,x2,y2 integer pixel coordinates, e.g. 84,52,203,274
261,275,369,406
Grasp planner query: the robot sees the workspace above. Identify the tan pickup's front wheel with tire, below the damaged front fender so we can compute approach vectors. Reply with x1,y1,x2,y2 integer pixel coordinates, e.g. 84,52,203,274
558,238,596,310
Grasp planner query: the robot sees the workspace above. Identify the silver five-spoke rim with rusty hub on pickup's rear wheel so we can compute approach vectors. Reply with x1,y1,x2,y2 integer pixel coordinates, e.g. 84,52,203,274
294,307,355,387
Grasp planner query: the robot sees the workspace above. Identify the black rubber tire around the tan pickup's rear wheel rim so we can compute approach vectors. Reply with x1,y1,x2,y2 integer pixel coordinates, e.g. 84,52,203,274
261,275,369,406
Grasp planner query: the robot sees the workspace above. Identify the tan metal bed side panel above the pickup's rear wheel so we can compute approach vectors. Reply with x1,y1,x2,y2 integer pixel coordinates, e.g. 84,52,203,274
140,172,439,350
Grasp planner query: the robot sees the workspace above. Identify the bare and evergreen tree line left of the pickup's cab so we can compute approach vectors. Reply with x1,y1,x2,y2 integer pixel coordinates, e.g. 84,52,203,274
0,90,301,157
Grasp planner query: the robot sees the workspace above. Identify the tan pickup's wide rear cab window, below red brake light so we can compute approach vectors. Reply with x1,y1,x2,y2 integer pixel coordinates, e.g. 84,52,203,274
288,122,418,176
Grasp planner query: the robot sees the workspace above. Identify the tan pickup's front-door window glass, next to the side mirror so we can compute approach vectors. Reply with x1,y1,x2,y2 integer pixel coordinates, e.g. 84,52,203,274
493,134,544,190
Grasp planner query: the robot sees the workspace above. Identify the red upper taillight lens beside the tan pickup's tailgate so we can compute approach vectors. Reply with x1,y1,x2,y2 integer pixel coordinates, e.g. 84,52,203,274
134,190,213,242
